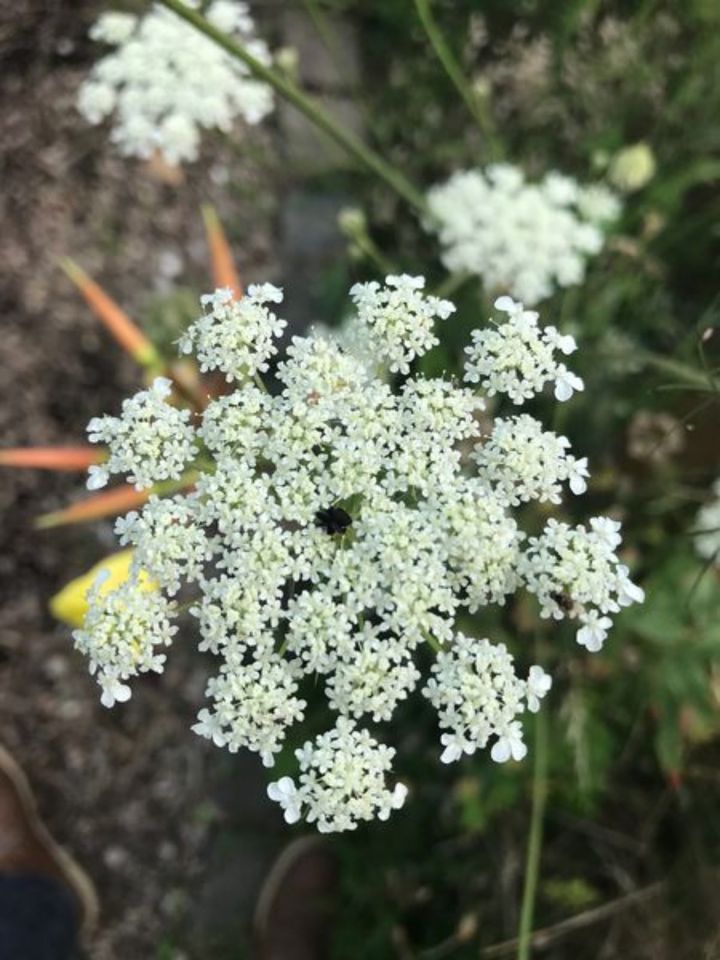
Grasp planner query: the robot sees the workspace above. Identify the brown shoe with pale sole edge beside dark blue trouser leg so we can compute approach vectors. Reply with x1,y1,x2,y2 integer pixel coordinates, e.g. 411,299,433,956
0,746,98,933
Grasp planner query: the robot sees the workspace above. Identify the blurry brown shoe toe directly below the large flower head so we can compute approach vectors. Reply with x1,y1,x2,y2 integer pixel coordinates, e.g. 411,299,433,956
255,837,338,960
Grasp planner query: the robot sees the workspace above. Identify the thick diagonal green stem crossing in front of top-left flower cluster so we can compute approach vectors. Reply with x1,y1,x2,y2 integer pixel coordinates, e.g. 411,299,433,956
158,0,427,213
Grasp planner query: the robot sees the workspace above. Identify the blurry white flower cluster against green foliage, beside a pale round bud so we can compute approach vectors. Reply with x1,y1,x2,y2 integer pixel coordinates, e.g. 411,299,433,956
426,163,620,306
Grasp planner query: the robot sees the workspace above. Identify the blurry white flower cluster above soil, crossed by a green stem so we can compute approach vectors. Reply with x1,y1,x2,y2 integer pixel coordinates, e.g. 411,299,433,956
78,0,273,165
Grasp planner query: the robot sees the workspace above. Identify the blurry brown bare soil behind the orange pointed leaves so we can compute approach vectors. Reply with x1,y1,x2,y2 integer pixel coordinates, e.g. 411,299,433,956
0,0,273,960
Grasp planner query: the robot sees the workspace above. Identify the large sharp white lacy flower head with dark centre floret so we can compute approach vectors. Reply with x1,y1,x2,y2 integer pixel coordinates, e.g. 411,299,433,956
76,276,642,831
